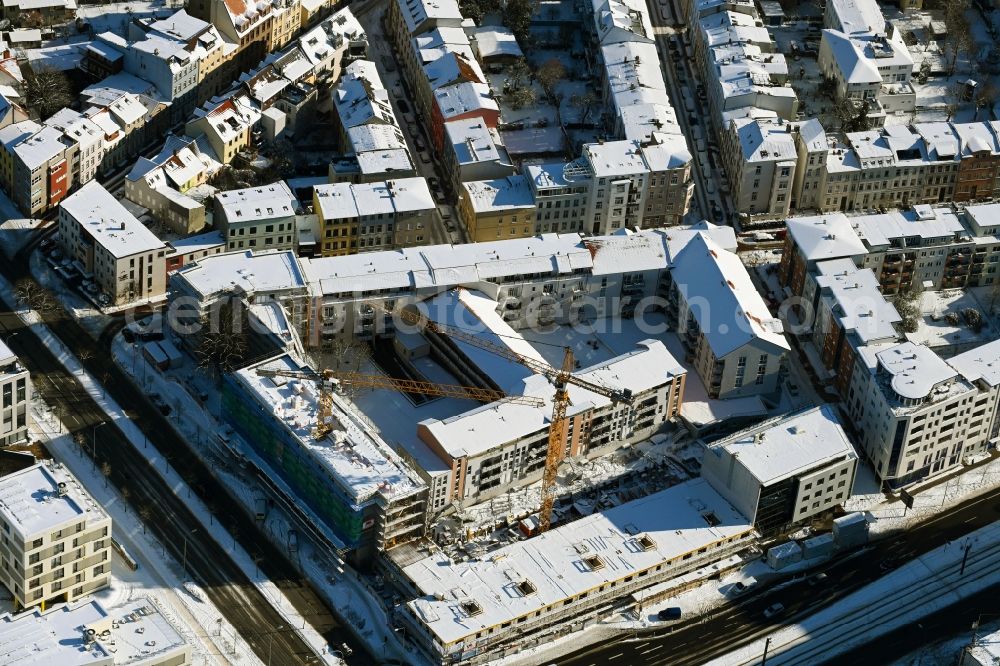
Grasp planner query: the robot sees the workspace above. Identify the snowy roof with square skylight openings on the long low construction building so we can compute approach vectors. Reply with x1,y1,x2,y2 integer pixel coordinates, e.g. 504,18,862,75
404,479,753,644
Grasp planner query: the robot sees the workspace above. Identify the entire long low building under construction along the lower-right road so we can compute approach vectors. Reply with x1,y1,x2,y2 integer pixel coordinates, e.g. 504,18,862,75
400,479,755,664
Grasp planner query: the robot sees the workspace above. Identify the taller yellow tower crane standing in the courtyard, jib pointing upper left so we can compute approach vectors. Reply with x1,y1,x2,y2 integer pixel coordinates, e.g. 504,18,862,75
382,298,632,532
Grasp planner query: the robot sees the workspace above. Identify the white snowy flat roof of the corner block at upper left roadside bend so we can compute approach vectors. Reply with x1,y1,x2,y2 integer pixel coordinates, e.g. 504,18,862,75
61,180,165,259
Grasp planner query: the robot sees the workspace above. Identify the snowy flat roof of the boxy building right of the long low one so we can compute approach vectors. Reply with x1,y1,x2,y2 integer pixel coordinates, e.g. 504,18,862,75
705,405,857,486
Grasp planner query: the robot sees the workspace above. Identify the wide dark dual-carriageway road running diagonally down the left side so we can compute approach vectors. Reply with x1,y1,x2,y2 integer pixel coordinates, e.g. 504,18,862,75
0,240,374,664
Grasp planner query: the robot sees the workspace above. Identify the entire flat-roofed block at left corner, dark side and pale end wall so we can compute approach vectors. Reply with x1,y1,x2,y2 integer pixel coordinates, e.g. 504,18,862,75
59,181,166,306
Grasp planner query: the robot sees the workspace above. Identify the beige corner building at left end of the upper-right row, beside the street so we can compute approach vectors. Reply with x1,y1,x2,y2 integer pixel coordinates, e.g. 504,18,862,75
722,118,798,217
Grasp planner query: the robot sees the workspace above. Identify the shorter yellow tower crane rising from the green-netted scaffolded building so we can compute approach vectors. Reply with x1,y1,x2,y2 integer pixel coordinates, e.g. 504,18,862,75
256,368,545,439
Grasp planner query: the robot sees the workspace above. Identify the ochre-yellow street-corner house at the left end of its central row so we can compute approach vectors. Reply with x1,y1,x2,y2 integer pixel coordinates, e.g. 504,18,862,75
458,174,535,242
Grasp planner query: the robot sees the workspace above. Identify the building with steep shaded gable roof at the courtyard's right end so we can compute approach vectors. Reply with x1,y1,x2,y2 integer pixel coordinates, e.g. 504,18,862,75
663,234,790,399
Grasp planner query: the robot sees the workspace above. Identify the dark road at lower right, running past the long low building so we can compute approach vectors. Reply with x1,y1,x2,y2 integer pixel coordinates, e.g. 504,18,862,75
556,482,1000,666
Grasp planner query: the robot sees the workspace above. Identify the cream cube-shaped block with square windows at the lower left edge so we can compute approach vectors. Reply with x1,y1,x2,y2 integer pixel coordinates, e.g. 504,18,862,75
0,462,111,610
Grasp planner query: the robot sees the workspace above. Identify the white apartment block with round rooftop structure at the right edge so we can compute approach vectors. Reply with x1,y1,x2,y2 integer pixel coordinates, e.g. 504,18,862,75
846,342,996,488
